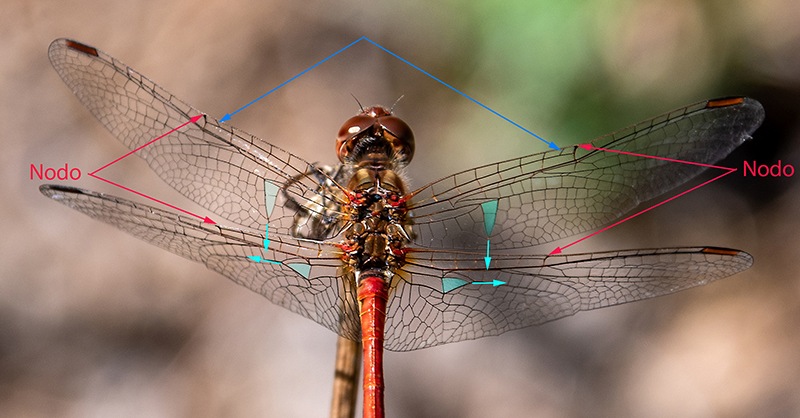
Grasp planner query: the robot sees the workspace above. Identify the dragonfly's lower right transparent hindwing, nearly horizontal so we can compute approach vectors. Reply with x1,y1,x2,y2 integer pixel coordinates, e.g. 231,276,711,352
385,247,753,351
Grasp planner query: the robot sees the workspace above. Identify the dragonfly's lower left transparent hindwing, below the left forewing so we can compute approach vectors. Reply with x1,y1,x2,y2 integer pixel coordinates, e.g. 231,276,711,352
40,185,361,339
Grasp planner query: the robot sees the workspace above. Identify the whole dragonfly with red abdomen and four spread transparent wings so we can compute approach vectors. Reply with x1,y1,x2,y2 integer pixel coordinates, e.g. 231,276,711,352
40,39,764,417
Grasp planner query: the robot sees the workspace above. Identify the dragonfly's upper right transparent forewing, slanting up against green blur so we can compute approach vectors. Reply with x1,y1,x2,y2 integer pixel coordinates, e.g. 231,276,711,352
411,98,764,249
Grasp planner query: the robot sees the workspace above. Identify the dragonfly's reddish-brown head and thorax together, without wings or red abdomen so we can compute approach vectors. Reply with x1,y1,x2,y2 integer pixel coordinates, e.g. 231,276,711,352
336,106,414,278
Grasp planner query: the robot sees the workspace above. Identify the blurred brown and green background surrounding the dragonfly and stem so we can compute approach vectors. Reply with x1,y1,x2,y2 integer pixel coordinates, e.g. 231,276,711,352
0,0,800,417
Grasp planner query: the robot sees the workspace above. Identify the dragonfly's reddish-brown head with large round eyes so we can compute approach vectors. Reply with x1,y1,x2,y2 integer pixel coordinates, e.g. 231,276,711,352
336,106,414,166
